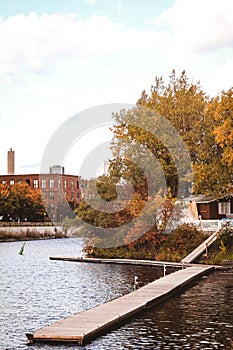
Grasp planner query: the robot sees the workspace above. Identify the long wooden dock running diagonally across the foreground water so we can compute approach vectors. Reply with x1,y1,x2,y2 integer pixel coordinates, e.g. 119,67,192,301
27,266,214,345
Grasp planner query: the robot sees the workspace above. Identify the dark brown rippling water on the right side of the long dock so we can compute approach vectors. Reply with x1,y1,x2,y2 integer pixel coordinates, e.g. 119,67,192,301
88,271,233,350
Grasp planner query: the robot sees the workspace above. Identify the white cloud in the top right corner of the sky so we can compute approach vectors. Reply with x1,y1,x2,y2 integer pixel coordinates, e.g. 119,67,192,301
155,0,233,52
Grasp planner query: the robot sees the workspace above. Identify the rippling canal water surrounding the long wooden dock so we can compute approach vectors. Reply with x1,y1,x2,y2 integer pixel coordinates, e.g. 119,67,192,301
0,238,233,350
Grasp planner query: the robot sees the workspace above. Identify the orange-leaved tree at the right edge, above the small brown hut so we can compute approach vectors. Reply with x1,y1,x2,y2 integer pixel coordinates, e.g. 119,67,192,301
194,89,233,196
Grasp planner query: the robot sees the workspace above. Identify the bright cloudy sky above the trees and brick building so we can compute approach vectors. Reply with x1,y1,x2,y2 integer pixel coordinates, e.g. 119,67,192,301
0,0,233,177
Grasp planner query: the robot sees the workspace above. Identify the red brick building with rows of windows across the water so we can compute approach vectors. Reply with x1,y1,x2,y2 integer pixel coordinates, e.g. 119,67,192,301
0,170,81,221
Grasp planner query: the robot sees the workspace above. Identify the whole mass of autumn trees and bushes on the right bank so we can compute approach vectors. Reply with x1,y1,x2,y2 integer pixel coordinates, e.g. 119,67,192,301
64,70,233,261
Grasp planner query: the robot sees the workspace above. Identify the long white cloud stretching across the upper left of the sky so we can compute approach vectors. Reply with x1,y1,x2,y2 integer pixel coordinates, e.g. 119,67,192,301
0,13,167,75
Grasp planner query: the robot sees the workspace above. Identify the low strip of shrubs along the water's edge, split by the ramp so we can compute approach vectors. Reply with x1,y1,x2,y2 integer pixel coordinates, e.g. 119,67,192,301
82,224,233,264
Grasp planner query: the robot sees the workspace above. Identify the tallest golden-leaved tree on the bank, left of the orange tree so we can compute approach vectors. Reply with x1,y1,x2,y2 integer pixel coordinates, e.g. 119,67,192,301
110,70,209,197
